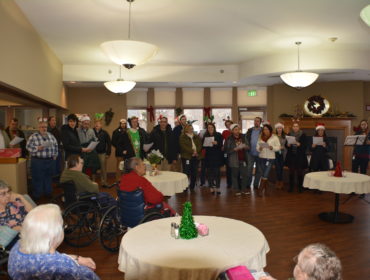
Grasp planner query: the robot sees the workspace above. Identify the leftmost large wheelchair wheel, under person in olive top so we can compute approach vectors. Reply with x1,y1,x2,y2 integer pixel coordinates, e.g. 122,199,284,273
63,201,100,247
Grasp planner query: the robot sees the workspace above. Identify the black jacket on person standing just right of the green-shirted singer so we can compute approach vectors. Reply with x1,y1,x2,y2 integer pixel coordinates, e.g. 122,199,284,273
148,125,176,163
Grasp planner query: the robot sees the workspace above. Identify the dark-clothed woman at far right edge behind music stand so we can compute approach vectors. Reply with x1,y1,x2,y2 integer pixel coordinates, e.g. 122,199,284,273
352,120,370,174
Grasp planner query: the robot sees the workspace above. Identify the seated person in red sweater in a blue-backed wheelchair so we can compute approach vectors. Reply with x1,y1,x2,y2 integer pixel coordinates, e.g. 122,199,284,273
120,157,176,215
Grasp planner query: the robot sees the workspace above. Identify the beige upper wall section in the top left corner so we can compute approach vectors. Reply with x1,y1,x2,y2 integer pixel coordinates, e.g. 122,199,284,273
0,0,66,107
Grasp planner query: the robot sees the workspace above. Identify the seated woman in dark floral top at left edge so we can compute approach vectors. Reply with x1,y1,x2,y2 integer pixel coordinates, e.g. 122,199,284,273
0,180,32,248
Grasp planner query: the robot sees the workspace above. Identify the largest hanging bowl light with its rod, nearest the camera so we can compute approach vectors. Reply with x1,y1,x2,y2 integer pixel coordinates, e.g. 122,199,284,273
100,0,158,69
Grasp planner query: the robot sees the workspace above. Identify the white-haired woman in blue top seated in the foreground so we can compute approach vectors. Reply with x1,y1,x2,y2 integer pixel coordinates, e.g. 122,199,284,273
8,204,99,280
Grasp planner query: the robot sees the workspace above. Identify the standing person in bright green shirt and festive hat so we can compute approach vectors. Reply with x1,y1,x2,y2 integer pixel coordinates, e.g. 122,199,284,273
124,116,148,159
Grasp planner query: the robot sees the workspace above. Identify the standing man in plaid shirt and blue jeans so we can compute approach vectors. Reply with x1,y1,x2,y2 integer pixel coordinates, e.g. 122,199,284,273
26,118,58,200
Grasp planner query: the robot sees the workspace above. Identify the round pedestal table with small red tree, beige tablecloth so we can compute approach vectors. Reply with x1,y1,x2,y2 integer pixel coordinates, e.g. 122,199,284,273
303,171,370,224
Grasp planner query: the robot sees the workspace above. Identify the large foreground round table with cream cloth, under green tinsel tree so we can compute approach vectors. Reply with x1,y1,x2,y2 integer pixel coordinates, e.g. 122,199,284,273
118,216,270,280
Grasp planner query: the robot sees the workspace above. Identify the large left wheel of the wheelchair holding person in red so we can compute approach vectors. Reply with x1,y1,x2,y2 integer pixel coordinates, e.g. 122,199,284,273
99,205,127,253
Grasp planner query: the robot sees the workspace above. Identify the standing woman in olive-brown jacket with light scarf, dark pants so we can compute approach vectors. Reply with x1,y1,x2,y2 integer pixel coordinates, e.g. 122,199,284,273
179,124,202,191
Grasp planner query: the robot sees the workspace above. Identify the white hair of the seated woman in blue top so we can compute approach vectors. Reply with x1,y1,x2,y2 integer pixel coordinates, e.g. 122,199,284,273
20,204,64,254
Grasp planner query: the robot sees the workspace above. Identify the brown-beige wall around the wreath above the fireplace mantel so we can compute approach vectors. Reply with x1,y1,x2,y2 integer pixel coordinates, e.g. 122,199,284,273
267,81,370,124
